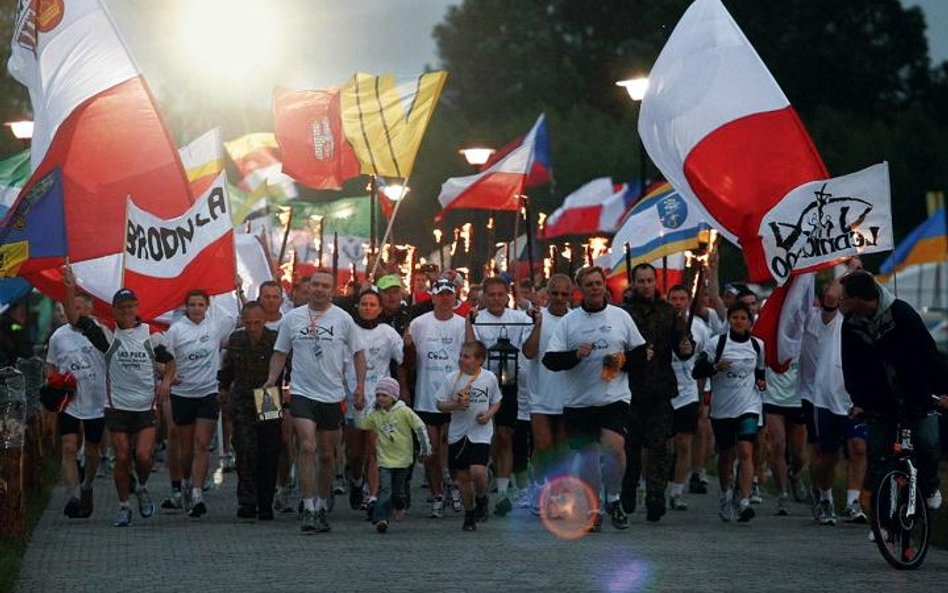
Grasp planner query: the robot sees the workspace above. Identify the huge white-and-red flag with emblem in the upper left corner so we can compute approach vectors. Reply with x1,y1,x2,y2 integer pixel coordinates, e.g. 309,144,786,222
8,0,192,314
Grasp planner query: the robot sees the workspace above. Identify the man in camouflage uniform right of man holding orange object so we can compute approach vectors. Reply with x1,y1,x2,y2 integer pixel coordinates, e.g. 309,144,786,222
622,263,694,522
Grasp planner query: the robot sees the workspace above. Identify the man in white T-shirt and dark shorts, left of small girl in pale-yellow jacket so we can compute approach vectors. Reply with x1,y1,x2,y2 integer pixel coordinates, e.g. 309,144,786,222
264,272,366,533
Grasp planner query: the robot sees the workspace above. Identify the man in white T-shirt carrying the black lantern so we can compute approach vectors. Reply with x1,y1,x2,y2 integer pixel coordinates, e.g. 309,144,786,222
467,276,539,516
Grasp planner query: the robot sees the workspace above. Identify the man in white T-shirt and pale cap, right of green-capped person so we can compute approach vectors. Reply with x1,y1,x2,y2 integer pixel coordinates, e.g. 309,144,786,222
405,278,465,518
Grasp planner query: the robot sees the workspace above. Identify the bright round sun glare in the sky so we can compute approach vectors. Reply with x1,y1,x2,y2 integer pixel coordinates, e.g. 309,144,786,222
178,0,281,81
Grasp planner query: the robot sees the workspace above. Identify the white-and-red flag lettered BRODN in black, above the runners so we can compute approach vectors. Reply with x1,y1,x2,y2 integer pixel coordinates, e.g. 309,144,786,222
122,172,237,319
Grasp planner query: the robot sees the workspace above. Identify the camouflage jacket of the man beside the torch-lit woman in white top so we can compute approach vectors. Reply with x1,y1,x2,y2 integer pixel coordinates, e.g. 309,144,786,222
622,293,694,405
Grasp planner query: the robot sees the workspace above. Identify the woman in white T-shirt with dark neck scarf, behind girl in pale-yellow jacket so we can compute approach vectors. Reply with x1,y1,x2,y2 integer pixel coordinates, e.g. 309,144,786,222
345,286,404,517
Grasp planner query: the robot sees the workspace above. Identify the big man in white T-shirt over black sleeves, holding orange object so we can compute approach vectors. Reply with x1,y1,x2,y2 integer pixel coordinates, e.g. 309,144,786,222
543,266,650,531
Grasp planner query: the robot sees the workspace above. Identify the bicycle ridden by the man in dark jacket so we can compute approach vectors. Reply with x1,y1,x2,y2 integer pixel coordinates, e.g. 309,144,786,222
870,427,931,570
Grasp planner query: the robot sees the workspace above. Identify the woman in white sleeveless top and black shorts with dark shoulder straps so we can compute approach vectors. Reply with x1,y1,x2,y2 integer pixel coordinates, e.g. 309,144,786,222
695,302,767,522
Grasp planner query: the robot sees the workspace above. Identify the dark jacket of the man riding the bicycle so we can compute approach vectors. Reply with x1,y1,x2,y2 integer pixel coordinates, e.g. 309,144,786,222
841,294,948,418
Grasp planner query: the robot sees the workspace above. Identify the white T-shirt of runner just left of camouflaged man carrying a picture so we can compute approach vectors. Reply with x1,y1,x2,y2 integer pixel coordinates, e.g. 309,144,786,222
165,316,234,398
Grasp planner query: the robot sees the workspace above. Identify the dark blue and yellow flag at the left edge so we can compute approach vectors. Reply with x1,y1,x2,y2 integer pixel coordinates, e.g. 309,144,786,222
0,168,67,278
